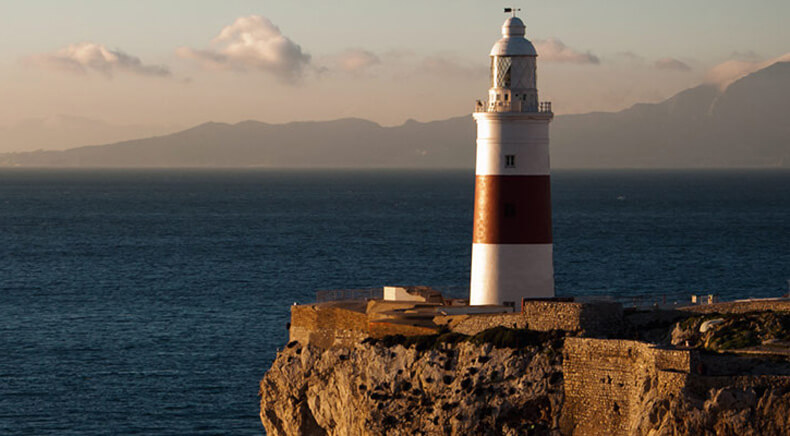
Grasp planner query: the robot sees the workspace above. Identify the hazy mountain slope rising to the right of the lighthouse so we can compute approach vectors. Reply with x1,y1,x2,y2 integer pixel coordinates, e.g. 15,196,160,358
551,62,790,168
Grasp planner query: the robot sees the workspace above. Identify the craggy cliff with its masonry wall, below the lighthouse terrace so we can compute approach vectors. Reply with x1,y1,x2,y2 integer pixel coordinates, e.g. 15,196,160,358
260,320,790,435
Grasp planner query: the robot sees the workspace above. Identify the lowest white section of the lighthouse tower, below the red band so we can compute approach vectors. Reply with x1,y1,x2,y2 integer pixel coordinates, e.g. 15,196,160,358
469,243,554,306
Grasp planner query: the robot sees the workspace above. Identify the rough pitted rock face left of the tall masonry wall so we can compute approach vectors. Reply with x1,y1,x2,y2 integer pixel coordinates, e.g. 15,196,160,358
260,341,564,435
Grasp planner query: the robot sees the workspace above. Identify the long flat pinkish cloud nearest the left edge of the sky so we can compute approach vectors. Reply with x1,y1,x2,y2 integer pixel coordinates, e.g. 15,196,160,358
23,42,172,78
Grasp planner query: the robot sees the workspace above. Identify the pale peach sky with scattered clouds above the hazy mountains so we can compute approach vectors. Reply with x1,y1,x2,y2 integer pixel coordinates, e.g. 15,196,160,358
0,0,790,152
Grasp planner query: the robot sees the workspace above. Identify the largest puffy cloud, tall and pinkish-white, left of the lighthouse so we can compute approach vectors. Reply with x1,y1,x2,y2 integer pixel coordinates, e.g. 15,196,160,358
176,15,311,84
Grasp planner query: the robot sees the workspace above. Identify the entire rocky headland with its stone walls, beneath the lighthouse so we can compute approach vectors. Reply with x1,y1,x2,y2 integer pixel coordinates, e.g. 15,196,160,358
260,301,790,436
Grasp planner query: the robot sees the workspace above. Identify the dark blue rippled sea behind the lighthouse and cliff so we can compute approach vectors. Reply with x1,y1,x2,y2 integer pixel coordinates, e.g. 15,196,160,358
0,170,790,435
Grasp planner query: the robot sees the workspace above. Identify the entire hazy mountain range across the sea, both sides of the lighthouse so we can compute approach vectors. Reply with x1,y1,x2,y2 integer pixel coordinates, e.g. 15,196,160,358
0,63,790,168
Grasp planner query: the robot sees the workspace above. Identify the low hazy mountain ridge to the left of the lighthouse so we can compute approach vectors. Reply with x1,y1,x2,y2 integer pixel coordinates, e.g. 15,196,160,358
0,117,475,167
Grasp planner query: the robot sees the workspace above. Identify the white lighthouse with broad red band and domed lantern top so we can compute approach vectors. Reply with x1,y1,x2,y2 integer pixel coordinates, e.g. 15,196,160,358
469,9,554,305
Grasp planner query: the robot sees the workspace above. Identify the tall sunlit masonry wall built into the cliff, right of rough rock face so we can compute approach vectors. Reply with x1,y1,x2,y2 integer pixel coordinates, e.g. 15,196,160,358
562,337,696,435
